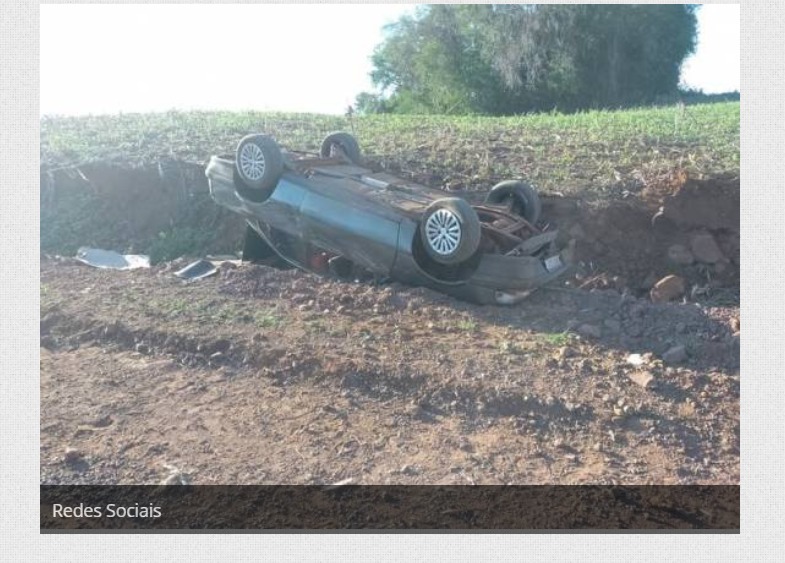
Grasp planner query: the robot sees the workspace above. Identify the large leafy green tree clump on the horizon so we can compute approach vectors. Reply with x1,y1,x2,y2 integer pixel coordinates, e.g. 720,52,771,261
358,4,697,114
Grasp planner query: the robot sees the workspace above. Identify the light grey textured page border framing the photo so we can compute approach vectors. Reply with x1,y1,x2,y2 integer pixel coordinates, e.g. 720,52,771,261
0,0,785,563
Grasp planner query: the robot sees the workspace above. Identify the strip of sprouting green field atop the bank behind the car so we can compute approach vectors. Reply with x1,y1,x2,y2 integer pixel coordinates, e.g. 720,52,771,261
41,102,740,194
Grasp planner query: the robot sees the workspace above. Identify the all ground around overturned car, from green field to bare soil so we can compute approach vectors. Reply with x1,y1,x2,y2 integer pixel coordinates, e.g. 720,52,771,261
40,102,740,498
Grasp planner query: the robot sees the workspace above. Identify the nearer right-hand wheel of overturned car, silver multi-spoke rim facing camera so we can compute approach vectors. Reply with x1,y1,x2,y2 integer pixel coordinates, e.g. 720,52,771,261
420,197,481,264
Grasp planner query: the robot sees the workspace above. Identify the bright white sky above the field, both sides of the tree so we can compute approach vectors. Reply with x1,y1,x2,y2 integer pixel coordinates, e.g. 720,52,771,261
40,4,740,115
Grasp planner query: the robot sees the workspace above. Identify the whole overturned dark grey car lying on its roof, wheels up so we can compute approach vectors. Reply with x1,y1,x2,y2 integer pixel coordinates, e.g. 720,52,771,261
206,133,571,304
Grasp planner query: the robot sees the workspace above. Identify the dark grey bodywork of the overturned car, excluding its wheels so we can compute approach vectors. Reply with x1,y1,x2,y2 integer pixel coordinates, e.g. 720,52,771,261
206,144,572,304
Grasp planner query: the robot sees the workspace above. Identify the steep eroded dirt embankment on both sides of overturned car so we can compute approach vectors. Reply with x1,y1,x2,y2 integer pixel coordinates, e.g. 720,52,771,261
41,160,740,295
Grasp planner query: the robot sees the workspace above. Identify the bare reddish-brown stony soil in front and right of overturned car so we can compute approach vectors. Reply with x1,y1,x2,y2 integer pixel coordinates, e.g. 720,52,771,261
41,180,740,490
